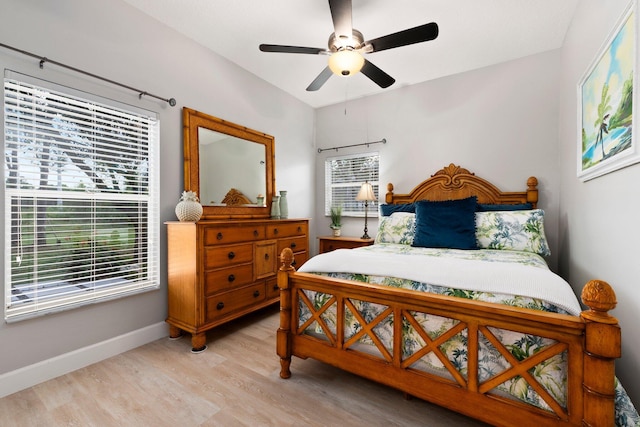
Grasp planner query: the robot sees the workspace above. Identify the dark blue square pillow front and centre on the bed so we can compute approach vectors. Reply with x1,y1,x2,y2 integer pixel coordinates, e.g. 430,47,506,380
412,196,478,249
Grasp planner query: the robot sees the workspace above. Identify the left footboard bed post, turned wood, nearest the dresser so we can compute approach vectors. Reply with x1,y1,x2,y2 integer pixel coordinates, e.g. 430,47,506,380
276,248,296,379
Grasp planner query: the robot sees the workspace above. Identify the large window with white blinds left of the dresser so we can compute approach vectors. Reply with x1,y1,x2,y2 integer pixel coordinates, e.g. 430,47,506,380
4,72,159,321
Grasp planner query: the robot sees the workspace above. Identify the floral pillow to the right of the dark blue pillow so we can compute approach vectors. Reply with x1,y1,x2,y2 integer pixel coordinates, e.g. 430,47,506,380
476,209,551,256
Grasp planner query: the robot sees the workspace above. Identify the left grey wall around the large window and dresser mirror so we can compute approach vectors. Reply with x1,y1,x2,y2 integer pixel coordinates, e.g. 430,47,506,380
0,0,315,396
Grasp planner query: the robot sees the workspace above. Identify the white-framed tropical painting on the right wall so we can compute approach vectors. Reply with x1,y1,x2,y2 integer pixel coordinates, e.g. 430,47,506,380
577,0,640,181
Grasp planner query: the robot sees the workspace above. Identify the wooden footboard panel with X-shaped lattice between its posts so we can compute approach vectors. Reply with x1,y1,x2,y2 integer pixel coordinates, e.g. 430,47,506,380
279,273,600,425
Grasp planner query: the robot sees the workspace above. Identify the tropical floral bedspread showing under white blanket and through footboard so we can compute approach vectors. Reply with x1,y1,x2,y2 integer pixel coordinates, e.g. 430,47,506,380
300,244,640,427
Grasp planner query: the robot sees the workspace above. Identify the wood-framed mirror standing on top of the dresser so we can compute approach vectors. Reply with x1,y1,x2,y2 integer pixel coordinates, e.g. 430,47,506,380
183,107,275,219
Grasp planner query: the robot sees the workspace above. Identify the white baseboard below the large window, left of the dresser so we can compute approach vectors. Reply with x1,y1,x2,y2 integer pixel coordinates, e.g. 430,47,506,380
0,322,169,398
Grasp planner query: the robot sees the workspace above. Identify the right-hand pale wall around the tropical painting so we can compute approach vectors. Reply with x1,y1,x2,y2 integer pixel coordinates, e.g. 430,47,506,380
559,0,640,405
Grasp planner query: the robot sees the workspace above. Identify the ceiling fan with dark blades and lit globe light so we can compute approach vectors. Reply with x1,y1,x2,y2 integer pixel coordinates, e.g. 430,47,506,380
260,0,438,91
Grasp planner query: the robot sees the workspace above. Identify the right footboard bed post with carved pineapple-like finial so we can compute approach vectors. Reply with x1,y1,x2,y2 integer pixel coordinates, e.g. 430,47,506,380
580,280,621,426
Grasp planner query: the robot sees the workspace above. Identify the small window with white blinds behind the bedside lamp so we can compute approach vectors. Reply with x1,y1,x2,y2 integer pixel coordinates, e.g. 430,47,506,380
324,153,380,216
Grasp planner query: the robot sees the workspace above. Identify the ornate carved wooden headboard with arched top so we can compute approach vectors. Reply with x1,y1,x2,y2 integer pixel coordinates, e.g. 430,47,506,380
385,163,538,208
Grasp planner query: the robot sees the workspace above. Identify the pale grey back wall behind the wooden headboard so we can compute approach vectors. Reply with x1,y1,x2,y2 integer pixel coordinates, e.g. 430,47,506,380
315,51,559,268
